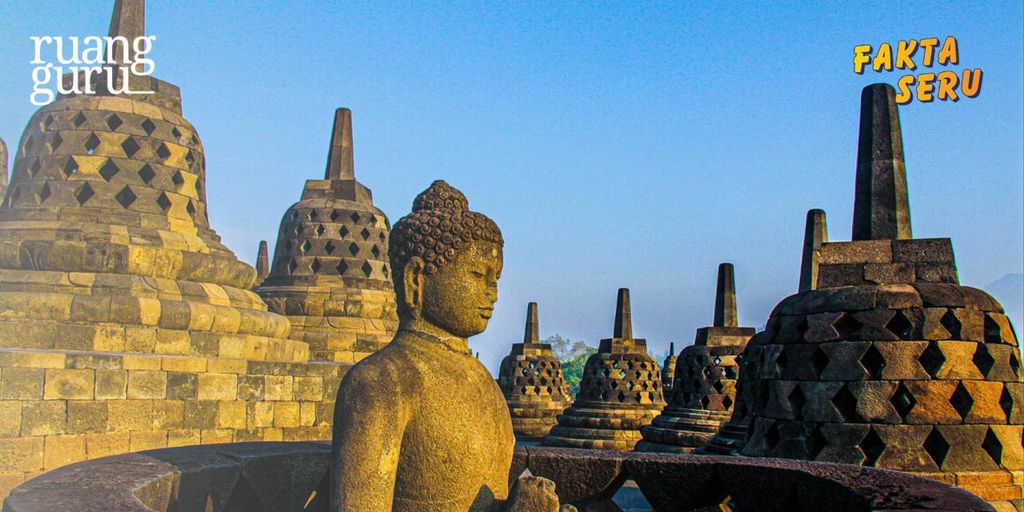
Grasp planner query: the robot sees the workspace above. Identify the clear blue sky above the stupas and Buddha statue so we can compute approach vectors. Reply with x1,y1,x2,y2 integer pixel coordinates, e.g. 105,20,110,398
0,0,1024,369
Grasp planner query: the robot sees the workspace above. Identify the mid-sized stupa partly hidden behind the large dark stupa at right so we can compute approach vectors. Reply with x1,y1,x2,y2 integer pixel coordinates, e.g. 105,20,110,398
637,263,755,453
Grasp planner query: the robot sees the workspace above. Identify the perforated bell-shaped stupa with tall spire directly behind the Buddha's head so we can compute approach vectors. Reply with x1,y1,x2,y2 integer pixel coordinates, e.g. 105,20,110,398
256,109,398,361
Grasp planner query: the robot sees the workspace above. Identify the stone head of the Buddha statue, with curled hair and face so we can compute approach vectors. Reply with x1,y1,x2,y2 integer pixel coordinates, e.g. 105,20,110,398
388,180,504,338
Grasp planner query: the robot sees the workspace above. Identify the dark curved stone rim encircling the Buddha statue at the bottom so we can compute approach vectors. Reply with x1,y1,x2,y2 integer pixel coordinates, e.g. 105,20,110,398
3,442,993,512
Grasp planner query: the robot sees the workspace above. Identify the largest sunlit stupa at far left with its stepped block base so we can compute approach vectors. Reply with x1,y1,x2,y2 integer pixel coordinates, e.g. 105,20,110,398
0,0,346,497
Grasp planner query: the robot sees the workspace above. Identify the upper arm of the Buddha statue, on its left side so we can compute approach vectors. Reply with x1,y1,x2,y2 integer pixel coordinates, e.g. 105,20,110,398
331,366,408,512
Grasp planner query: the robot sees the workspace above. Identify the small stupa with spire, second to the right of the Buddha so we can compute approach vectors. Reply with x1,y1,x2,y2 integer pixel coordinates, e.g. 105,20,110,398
544,288,665,450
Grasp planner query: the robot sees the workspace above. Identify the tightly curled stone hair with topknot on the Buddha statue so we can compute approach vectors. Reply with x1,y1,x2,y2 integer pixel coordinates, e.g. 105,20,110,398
387,179,504,275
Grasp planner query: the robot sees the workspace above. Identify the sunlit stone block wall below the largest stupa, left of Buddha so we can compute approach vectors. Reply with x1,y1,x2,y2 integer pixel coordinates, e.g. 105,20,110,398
0,349,349,498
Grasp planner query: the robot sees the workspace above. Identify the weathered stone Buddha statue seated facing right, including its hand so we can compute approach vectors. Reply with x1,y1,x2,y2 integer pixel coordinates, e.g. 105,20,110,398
331,181,558,512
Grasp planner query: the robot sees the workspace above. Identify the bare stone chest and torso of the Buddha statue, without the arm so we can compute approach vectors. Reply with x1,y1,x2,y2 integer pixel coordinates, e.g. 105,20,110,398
385,335,515,512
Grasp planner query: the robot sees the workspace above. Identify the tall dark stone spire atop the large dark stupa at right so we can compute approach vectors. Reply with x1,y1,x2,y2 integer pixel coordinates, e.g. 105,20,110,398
853,84,912,241
